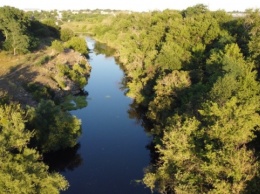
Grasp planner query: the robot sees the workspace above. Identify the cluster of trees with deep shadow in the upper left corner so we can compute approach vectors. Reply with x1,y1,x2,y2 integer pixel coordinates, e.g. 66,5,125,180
0,6,59,55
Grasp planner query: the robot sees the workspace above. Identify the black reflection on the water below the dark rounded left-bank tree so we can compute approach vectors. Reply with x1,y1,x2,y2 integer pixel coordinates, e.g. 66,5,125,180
43,143,83,172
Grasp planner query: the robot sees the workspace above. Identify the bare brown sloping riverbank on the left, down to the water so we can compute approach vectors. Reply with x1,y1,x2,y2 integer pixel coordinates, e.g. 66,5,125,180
0,48,91,106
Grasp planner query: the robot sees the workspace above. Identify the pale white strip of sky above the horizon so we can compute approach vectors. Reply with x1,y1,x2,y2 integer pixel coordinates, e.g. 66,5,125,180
0,0,260,11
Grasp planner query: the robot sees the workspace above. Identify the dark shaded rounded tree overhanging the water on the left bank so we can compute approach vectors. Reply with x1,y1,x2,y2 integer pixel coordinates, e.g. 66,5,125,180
30,100,81,152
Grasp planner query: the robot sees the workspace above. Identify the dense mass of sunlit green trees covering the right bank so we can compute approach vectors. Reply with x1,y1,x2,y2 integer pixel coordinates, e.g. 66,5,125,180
86,5,260,193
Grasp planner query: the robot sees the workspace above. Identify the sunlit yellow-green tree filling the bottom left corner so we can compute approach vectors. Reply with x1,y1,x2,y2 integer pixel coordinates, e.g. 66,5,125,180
0,105,68,194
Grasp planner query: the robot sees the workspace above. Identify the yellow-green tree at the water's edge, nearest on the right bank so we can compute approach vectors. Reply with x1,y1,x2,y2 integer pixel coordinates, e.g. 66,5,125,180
143,117,203,193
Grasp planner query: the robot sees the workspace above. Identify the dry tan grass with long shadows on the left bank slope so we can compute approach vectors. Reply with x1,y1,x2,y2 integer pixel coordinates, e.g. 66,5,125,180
0,42,90,105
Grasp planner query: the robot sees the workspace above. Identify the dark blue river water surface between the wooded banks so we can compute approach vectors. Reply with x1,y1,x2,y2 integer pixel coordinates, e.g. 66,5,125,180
61,38,151,194
